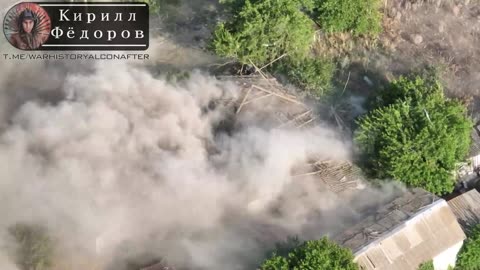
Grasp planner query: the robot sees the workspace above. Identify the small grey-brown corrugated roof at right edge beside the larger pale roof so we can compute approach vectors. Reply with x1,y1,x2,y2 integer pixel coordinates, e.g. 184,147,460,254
448,189,480,231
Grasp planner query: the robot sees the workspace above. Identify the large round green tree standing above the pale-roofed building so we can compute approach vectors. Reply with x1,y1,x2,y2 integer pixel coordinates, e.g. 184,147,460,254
355,77,472,195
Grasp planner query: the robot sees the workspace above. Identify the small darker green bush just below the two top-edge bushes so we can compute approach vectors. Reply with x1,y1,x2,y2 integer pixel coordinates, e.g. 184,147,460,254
279,58,335,97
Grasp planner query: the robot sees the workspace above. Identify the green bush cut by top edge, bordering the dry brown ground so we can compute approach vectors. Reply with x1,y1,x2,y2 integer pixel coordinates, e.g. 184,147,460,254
314,0,382,34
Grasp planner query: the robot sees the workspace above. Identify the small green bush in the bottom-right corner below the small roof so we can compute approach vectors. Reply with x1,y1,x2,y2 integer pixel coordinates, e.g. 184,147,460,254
455,225,480,270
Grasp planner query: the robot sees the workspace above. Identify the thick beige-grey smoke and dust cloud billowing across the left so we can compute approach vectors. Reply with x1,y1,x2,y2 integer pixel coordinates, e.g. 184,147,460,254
0,59,404,270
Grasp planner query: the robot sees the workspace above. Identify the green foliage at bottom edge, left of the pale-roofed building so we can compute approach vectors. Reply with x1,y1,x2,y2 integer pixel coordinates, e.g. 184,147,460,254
260,238,358,270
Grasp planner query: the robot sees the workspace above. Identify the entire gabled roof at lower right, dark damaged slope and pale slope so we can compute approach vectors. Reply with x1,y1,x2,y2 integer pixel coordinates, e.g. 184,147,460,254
334,189,465,270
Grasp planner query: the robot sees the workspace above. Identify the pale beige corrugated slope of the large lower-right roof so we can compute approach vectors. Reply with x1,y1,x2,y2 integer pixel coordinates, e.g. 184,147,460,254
355,200,465,270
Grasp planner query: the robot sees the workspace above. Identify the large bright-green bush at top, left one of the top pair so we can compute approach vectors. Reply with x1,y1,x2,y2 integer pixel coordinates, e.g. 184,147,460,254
211,0,314,65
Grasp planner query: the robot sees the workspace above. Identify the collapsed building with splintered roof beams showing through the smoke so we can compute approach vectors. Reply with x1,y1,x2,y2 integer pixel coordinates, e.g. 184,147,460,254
219,72,366,195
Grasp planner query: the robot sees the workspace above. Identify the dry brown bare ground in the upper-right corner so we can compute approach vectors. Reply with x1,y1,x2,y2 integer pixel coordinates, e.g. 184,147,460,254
344,0,480,104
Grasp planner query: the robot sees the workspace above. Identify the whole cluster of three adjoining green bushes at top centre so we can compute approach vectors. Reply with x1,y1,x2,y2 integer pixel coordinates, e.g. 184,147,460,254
210,0,382,98
